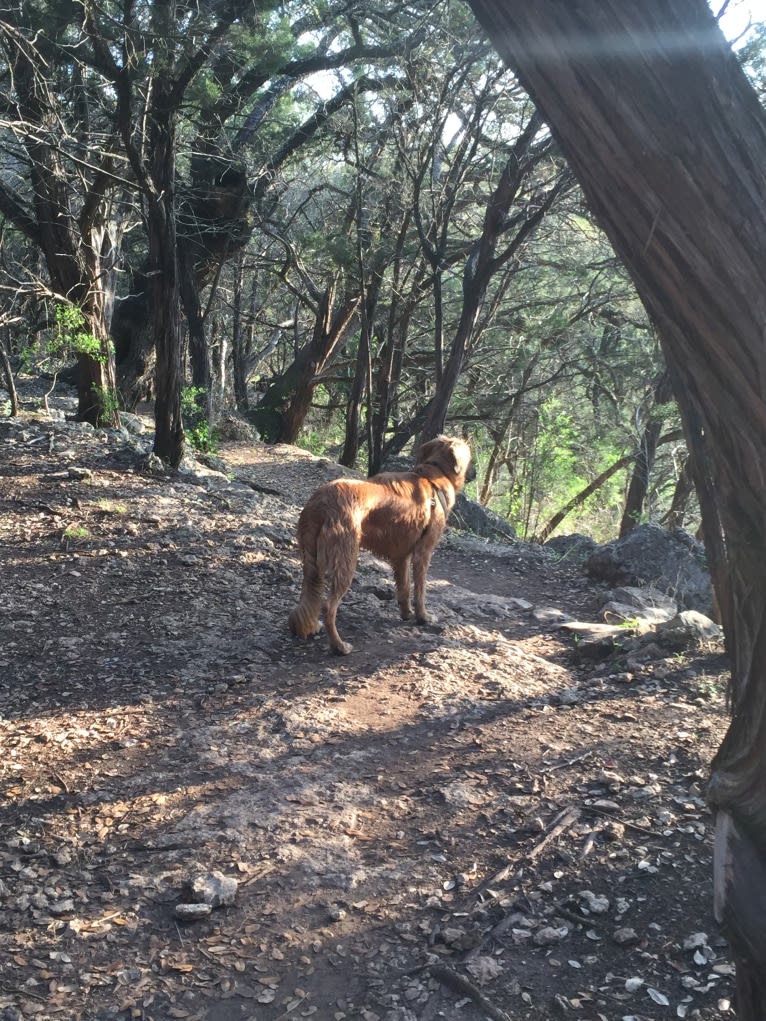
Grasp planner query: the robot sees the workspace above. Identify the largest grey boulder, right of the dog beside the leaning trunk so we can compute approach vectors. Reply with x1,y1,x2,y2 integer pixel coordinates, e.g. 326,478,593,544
586,525,713,616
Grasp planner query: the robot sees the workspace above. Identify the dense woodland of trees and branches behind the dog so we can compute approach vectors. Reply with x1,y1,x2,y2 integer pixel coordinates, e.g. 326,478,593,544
0,0,763,538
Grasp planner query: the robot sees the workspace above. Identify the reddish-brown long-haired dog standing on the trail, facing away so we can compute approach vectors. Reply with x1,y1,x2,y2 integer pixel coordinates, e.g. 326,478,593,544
289,436,475,655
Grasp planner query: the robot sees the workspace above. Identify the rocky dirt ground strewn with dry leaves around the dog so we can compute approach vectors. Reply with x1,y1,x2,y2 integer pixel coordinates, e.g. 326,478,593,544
0,383,733,1021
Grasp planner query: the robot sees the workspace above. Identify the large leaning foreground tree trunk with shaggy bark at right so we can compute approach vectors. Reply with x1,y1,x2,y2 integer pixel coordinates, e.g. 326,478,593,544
470,0,766,1004
